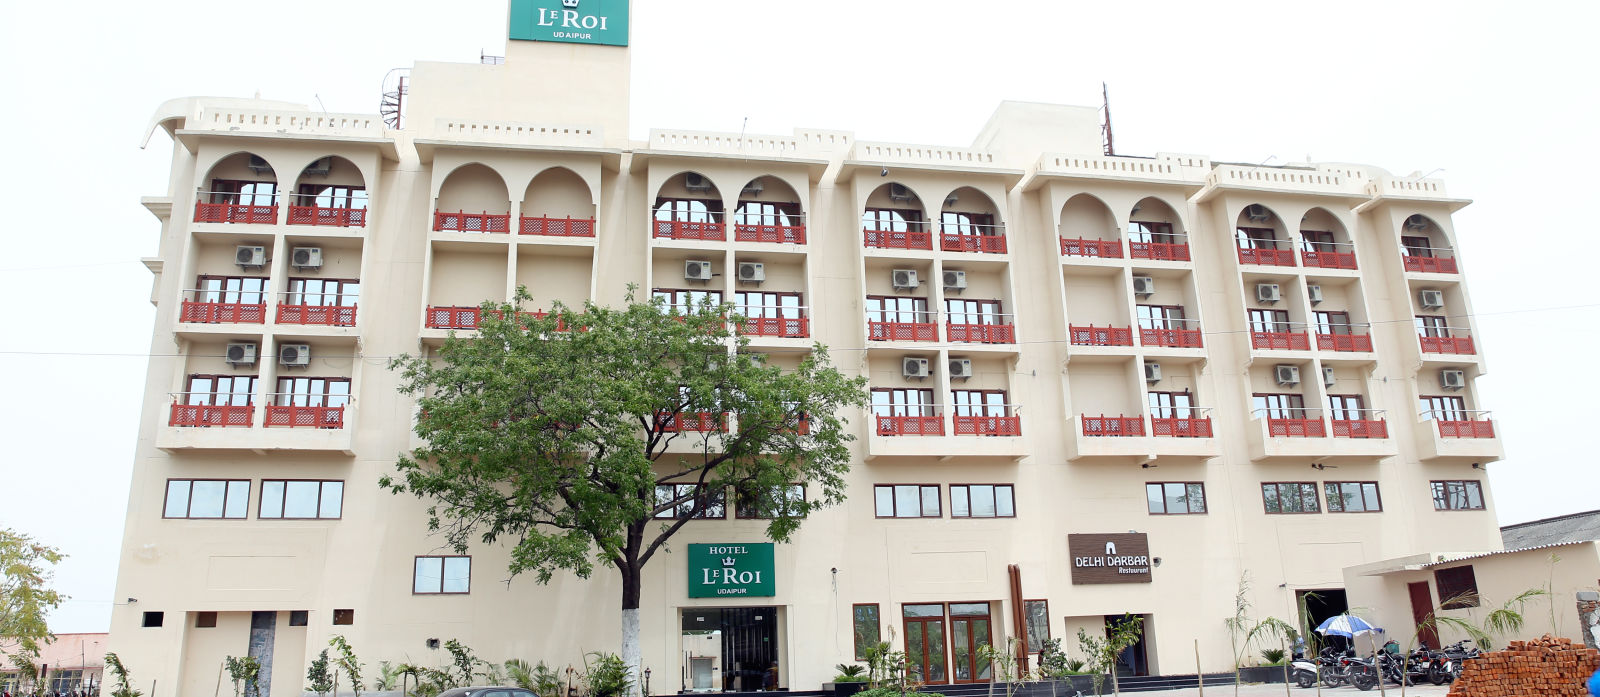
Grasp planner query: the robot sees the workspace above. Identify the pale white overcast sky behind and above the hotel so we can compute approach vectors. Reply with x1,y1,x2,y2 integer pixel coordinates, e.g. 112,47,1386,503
0,0,1600,631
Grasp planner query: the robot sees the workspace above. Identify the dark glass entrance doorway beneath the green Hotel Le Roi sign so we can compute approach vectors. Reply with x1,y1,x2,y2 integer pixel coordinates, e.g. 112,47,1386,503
680,607,782,692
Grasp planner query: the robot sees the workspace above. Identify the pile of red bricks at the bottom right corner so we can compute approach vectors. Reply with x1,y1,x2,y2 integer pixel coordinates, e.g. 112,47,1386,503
1450,635,1600,697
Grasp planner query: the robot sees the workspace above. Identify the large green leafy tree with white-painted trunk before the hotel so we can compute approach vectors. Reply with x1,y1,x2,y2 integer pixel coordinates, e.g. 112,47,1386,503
382,289,866,684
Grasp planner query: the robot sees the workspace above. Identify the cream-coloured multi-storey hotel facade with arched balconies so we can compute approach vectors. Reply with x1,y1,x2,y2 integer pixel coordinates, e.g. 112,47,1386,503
112,8,1501,697
